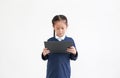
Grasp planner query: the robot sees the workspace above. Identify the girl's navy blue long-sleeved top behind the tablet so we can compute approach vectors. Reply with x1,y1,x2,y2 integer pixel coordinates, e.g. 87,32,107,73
42,37,78,78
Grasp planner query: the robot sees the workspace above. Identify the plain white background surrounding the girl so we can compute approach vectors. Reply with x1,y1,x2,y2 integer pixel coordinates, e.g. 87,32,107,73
0,0,120,78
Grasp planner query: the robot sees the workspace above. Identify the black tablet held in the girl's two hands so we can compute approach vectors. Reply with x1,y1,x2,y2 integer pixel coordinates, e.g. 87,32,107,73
44,41,73,53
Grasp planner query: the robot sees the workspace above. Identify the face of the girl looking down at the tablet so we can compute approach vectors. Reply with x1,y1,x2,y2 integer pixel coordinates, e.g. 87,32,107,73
53,21,67,37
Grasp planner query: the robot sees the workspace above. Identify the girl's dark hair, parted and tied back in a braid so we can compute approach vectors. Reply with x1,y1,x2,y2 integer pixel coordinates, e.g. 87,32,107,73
52,15,68,37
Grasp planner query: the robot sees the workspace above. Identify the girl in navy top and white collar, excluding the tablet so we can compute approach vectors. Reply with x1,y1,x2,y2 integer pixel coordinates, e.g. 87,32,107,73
42,15,78,78
